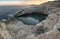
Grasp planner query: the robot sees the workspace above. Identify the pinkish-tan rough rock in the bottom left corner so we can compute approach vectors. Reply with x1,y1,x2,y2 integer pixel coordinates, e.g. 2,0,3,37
0,23,12,39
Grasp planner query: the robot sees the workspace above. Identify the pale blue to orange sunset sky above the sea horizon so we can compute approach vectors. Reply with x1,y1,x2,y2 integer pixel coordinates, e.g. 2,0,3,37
0,0,53,6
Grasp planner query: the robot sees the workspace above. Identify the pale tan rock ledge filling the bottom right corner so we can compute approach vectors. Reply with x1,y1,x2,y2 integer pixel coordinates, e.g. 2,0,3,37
35,21,60,39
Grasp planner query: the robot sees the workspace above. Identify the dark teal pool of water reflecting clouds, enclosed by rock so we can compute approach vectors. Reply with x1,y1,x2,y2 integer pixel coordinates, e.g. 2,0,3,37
17,14,47,25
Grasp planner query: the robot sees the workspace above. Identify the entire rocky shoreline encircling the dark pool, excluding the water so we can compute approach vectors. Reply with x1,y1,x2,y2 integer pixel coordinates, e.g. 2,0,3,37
0,1,60,39
